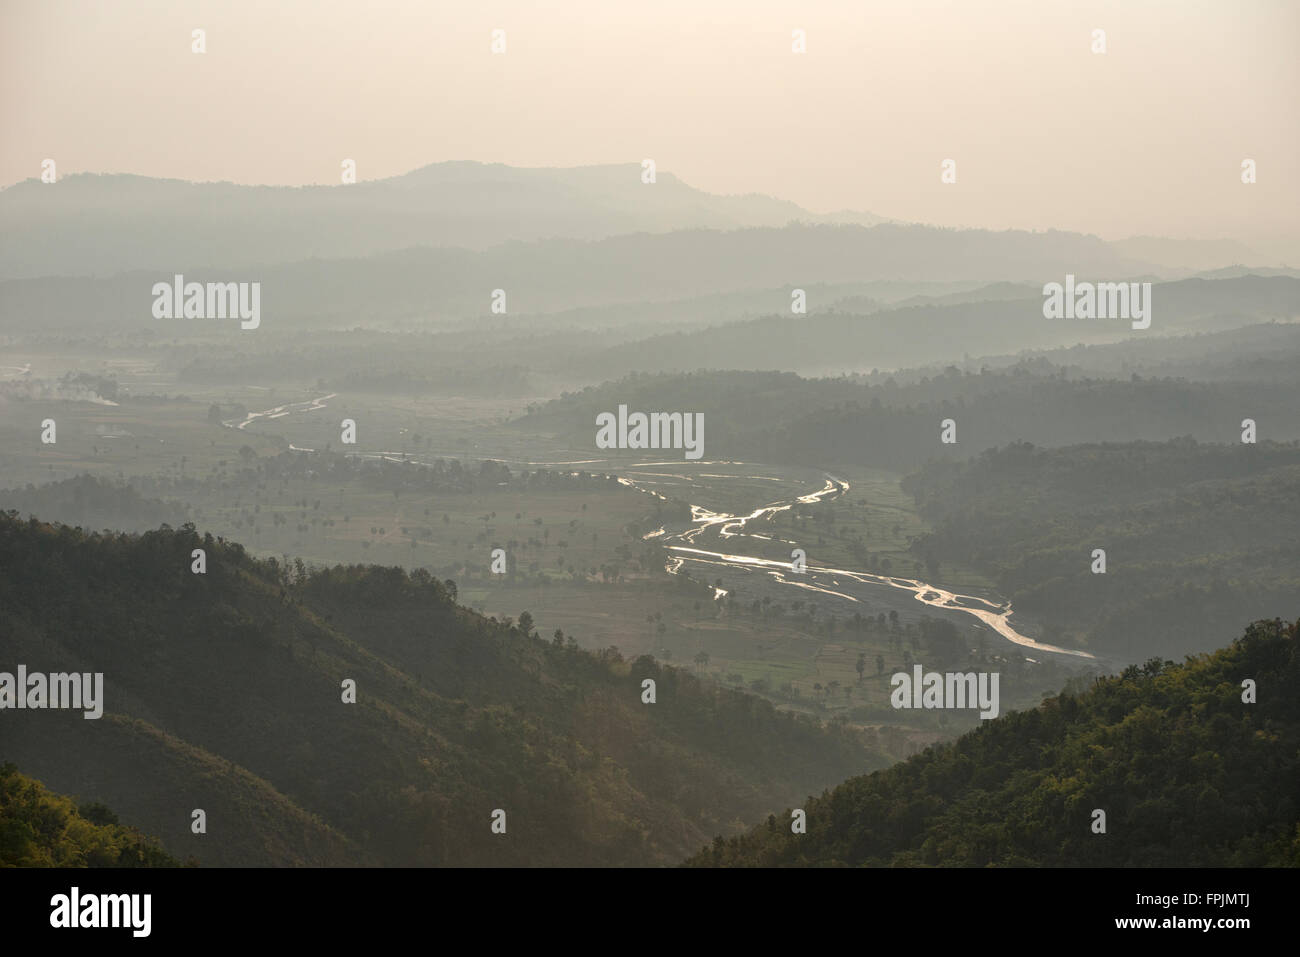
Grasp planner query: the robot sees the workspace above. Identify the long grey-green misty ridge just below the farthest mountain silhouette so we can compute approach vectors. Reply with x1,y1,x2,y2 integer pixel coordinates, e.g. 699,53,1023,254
0,221,1159,337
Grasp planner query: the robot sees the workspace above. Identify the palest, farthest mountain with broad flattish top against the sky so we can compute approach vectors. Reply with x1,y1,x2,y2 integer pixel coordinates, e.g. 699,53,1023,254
0,160,884,280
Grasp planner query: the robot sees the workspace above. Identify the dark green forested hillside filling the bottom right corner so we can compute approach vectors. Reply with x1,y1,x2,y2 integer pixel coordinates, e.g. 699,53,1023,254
689,620,1300,867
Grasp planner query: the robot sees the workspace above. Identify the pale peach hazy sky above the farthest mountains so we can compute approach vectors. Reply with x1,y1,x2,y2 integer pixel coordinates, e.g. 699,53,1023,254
0,0,1300,247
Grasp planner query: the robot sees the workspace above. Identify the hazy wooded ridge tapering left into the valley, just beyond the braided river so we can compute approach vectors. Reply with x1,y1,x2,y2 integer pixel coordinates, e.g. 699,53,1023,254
517,356,1300,472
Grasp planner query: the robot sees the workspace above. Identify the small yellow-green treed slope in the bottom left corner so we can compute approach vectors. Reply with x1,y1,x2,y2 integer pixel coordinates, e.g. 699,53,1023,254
0,765,179,867
